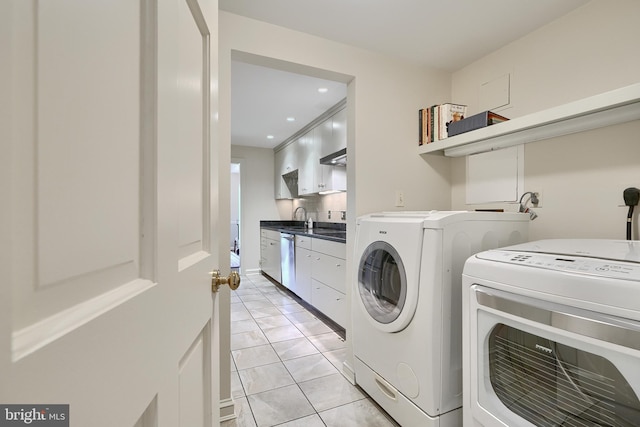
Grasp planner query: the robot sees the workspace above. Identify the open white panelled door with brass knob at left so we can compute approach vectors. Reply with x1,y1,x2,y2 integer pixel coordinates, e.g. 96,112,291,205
0,0,227,427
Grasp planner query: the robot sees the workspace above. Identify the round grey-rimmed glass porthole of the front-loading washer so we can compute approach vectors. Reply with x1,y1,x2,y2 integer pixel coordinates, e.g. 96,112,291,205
358,241,407,324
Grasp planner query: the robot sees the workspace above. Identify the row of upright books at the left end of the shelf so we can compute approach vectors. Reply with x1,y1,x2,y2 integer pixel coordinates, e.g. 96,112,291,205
418,102,467,145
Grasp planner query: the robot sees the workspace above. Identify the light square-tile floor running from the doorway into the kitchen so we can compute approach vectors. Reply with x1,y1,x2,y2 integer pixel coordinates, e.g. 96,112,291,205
221,275,397,427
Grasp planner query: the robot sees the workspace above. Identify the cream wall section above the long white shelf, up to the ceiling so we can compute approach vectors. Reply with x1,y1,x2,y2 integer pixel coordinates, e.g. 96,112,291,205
451,0,640,118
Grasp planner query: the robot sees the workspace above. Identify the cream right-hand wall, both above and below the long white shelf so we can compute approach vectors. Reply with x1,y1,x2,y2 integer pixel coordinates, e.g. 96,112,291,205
452,0,640,239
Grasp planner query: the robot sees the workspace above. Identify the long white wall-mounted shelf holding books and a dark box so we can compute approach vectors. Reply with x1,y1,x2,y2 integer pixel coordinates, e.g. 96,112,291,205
418,83,640,157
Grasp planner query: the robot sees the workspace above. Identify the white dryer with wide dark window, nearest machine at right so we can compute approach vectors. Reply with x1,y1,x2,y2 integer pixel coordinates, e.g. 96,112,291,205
462,239,640,427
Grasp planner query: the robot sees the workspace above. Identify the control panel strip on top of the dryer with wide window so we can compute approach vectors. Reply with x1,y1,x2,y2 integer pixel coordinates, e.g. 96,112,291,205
476,250,640,281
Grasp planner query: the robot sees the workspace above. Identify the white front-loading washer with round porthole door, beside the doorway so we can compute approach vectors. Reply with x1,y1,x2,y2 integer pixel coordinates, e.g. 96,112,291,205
352,211,529,427
